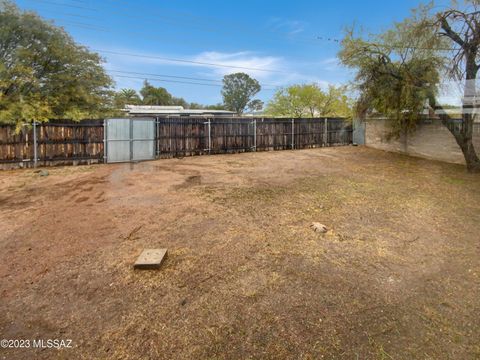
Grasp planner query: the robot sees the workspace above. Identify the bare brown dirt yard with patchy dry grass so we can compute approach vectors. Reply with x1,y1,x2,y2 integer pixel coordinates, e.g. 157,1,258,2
0,147,480,359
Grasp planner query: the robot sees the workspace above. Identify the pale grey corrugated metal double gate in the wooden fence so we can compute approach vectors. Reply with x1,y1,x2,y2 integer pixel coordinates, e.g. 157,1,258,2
105,118,155,163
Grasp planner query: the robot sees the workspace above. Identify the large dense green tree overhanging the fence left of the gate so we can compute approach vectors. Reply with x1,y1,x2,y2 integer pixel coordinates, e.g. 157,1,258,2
0,0,112,125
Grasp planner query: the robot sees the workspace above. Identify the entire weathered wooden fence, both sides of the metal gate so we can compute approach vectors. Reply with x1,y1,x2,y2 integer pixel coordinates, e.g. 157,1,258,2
0,117,352,168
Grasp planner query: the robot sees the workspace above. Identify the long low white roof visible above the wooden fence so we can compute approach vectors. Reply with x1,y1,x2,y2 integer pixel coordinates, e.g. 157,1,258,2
123,105,236,116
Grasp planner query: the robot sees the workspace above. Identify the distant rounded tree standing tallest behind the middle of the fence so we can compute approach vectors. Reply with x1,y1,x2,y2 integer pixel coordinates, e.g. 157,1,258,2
222,73,261,115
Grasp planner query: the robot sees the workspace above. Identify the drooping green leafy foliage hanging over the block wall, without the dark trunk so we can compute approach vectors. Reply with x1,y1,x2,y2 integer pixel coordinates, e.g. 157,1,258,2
339,4,442,136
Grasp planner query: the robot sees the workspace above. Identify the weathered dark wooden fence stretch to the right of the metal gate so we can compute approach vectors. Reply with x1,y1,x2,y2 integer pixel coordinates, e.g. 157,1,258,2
156,117,353,157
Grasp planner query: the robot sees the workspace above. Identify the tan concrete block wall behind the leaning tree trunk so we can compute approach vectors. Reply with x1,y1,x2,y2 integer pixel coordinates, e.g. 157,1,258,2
365,119,480,164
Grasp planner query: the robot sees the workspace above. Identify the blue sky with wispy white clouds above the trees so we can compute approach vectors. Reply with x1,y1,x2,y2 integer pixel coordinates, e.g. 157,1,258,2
17,0,447,104
